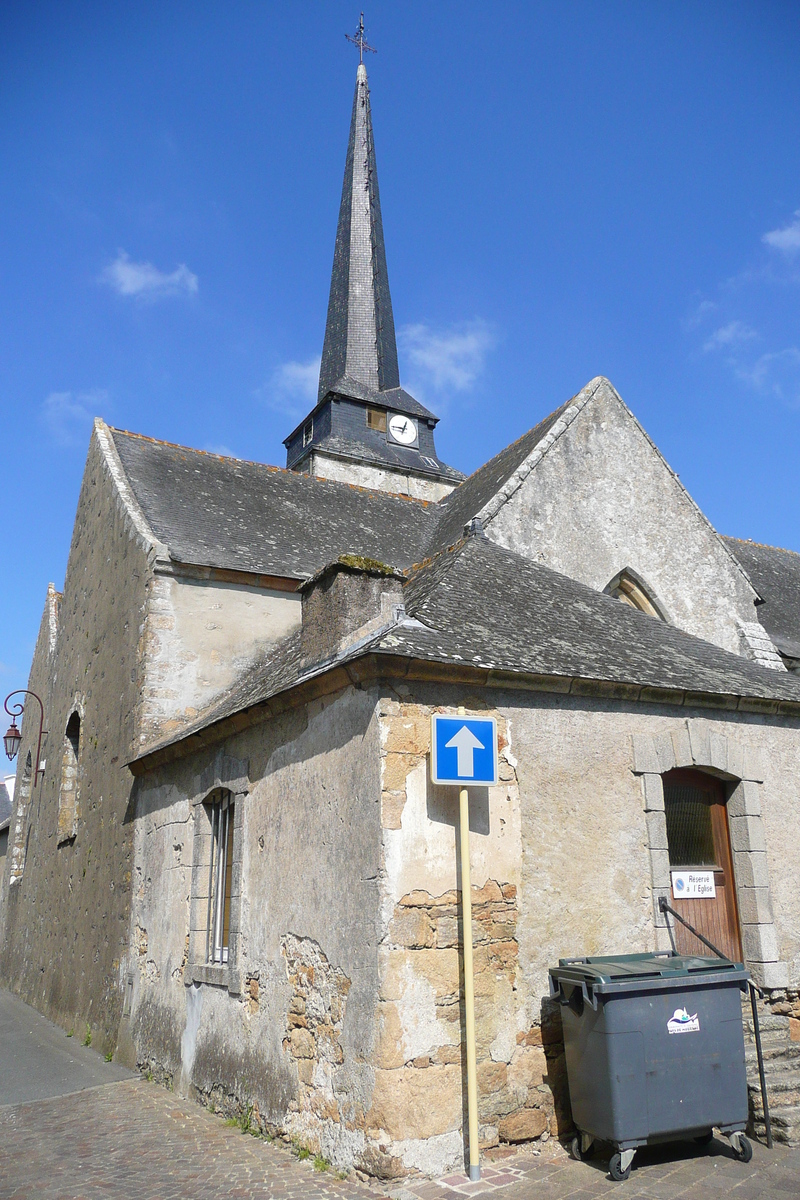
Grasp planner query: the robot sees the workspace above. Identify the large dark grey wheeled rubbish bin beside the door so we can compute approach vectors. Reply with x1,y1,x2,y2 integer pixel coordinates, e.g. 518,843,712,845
549,952,752,1180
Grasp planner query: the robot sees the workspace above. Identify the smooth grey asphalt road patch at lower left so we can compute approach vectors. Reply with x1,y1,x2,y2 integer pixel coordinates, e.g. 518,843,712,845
0,990,132,1104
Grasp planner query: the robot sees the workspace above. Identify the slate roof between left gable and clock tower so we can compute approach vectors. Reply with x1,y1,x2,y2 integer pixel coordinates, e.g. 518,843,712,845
110,430,435,578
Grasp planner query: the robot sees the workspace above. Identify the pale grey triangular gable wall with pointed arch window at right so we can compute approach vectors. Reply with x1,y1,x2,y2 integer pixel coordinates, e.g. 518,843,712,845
486,384,757,654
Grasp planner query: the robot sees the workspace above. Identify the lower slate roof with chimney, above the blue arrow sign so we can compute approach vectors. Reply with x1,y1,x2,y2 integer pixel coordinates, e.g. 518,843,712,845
133,536,800,758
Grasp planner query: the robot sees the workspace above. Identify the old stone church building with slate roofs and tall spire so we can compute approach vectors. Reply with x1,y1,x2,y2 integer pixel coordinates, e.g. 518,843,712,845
0,54,800,1178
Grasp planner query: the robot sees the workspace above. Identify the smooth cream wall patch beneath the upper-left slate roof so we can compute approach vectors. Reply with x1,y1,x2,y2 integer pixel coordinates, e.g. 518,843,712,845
138,570,301,745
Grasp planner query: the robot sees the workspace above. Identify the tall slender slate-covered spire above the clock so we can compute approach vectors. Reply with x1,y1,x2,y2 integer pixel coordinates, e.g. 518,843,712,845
318,62,399,401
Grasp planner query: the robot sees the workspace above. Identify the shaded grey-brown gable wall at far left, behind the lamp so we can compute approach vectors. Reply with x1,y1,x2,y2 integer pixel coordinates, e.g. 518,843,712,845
0,433,150,1050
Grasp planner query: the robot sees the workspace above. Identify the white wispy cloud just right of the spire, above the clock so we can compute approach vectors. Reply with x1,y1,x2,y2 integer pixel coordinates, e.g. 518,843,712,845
399,318,497,392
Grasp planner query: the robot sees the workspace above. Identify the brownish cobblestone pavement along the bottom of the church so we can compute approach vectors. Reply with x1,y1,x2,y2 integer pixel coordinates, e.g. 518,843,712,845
0,1079,800,1200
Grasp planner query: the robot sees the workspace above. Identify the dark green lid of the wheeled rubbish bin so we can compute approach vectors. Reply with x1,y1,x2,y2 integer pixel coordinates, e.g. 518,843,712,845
549,950,750,991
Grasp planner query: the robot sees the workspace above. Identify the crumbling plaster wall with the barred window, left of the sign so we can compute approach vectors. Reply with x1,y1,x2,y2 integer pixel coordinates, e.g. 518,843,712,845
126,689,380,1168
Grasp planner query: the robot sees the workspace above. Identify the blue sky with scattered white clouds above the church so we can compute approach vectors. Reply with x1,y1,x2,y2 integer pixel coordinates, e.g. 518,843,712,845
0,0,800,690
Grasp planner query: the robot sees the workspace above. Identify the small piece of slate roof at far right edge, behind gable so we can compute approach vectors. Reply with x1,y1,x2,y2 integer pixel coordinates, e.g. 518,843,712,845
722,538,800,659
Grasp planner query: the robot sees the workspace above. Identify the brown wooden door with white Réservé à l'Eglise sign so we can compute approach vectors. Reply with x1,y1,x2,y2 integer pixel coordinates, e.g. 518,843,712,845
663,770,742,962
